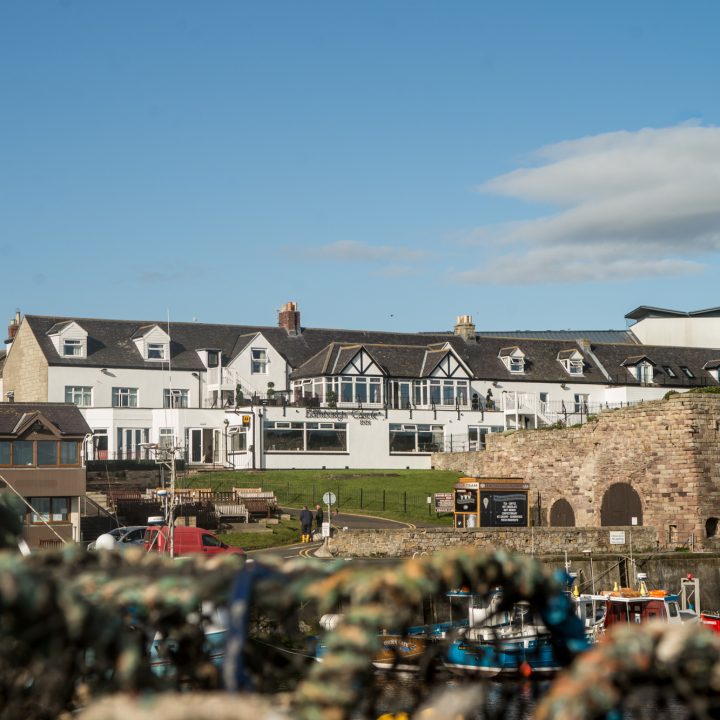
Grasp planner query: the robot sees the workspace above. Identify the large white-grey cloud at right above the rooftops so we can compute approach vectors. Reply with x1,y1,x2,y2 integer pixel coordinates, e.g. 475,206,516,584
454,125,720,283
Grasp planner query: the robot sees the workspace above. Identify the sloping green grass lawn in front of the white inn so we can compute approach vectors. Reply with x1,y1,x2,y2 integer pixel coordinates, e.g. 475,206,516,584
178,470,459,525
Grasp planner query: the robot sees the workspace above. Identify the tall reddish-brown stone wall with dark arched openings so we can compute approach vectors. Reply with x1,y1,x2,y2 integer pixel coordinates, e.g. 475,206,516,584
433,394,720,548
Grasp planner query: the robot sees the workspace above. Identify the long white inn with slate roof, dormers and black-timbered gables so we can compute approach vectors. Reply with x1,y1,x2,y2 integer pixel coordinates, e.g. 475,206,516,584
1,303,720,469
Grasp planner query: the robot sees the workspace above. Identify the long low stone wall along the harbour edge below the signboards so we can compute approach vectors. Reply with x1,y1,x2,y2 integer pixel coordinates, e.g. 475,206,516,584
328,527,657,558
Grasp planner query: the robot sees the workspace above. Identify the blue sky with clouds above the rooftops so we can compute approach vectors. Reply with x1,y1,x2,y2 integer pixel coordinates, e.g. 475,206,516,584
0,0,720,331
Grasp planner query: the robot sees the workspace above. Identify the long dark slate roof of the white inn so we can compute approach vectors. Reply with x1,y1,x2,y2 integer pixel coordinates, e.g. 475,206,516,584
16,315,718,386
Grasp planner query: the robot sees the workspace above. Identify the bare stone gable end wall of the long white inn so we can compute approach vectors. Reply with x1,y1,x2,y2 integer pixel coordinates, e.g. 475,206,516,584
3,322,48,402
